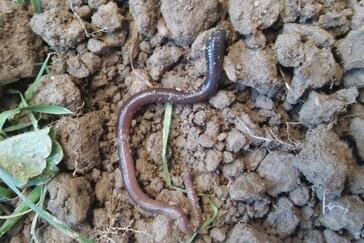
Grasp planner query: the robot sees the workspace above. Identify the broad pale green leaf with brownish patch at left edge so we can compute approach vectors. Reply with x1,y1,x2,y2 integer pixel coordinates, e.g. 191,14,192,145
0,128,52,186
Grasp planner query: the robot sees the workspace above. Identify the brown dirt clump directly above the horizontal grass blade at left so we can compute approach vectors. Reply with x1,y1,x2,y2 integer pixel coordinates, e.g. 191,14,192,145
30,74,82,111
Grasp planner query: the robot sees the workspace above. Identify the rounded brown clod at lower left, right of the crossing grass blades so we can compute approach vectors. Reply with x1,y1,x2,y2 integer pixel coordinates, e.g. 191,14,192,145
47,173,94,226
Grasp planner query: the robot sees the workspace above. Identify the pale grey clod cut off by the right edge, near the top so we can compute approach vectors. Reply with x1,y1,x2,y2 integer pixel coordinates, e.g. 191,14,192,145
337,26,364,71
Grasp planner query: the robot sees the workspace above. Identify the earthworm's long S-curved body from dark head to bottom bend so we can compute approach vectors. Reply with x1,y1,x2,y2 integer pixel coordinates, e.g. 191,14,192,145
117,31,225,234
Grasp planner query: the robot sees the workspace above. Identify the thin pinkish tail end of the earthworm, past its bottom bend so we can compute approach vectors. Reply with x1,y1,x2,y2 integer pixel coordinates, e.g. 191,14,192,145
183,171,202,225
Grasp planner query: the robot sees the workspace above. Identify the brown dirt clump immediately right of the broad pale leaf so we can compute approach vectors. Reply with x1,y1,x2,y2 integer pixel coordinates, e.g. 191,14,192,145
55,112,102,173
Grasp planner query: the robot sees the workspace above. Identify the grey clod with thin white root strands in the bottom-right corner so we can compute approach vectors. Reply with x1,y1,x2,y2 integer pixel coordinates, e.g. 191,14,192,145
319,196,364,239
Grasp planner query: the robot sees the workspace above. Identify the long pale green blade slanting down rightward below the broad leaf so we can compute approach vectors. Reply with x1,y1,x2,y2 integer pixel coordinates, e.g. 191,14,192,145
0,168,93,243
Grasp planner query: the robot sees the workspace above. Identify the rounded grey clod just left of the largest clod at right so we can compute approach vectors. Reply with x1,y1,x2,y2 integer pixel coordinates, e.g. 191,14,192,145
257,151,299,197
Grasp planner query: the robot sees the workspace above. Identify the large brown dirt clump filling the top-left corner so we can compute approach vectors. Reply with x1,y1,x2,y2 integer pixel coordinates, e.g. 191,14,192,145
0,8,40,86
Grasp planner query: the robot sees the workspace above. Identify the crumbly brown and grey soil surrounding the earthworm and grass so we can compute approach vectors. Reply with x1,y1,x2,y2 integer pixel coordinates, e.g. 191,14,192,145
0,0,364,242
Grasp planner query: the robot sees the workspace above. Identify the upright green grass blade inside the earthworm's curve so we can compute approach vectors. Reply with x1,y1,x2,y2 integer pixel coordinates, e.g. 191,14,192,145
162,103,185,192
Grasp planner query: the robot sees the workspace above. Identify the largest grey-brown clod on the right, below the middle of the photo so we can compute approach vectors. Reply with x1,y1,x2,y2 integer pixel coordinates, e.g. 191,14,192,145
293,125,353,199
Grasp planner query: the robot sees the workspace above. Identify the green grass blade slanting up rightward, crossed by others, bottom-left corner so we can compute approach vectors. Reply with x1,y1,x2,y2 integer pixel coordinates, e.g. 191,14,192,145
0,187,41,237
